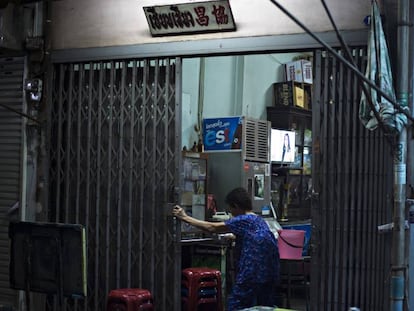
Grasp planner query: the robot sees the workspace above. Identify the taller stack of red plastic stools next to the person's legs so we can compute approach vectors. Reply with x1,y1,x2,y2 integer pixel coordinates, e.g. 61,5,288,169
181,267,223,311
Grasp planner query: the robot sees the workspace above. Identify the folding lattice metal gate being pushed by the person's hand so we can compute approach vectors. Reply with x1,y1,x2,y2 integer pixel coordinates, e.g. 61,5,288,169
48,58,181,311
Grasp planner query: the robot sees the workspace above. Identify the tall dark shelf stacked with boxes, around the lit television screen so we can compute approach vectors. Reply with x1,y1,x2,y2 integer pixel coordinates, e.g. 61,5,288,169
266,59,313,221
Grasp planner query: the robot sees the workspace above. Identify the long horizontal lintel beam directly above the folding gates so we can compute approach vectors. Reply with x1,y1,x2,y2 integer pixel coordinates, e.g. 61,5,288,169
51,28,368,63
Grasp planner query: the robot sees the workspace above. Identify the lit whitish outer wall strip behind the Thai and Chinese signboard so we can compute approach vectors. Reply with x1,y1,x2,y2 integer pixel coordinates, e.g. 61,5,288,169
51,0,371,49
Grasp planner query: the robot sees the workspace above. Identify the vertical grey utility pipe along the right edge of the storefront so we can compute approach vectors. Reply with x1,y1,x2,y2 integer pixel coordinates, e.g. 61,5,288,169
390,0,410,311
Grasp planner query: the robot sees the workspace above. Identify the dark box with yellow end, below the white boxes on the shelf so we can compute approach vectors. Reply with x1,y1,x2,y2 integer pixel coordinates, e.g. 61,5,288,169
273,81,307,108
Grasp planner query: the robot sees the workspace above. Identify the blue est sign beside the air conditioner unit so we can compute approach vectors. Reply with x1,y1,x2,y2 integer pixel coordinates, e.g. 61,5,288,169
203,117,243,151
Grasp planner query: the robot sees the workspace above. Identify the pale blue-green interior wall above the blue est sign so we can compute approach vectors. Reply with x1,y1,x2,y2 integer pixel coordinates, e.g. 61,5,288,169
182,53,309,148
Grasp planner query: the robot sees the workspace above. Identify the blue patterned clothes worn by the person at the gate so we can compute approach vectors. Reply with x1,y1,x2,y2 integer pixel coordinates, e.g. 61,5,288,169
225,214,280,311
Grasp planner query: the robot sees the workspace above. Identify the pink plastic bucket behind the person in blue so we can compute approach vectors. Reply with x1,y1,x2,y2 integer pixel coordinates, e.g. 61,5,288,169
278,229,305,259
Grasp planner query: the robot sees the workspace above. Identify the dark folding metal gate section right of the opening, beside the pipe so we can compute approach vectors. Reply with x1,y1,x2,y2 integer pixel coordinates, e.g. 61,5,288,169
311,48,393,311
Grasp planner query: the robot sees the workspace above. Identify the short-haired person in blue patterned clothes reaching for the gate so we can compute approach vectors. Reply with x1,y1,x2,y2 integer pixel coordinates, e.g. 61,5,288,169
173,188,280,311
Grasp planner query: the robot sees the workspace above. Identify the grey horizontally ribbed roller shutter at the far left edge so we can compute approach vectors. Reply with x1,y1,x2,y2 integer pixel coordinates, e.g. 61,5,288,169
0,57,26,307
